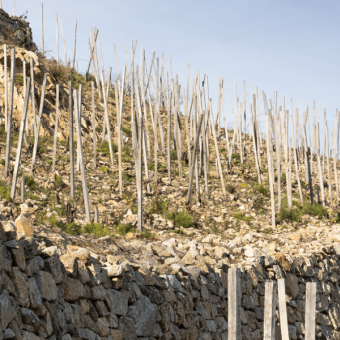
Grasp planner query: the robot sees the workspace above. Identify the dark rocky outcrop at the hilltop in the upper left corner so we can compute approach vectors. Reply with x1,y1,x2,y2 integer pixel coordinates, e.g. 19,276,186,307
0,9,37,51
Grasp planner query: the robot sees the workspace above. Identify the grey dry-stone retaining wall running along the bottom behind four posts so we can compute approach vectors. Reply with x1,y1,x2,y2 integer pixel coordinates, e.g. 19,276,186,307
0,222,340,340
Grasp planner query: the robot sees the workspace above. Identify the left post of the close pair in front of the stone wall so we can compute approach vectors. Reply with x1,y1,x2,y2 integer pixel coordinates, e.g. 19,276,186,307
263,281,277,340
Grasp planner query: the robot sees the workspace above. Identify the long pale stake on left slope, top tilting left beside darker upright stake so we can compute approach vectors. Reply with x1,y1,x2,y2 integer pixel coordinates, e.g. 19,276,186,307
73,90,91,222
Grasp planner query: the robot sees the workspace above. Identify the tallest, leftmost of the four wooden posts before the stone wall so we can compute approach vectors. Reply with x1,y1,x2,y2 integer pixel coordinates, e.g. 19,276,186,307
228,268,242,340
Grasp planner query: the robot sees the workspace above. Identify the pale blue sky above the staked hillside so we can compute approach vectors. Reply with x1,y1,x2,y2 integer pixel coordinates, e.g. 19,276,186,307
6,0,340,131
